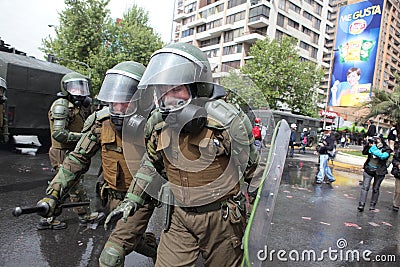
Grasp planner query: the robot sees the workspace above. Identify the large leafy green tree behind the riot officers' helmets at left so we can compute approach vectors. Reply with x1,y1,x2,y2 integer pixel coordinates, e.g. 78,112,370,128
41,0,164,95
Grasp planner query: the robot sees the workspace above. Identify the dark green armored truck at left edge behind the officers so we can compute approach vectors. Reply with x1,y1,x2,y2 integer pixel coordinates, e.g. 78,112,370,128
0,51,72,151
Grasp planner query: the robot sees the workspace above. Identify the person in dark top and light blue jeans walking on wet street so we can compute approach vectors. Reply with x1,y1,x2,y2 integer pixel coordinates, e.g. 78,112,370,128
314,126,336,184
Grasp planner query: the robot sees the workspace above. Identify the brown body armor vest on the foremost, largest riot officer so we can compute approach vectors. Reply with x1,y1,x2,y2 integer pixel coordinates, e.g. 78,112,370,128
157,127,239,206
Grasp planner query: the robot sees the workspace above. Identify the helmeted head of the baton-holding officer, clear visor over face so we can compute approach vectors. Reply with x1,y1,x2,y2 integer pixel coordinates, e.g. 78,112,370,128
97,61,146,130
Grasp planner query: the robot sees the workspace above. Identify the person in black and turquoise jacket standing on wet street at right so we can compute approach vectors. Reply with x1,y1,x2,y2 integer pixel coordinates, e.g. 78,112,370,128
358,135,392,211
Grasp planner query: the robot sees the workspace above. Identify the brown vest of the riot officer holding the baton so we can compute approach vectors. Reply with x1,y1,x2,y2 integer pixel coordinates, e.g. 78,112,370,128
101,119,132,192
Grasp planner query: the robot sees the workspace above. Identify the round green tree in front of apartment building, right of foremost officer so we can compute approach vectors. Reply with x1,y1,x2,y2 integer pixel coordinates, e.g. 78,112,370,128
242,37,324,116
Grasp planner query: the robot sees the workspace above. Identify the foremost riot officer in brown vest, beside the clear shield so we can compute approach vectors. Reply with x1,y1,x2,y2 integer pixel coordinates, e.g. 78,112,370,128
108,43,259,266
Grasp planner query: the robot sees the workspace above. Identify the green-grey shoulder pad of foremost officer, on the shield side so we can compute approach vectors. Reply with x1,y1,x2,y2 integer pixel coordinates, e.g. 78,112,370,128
206,100,254,145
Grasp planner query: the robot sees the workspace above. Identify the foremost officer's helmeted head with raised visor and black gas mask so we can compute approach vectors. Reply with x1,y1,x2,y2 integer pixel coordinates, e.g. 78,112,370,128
138,43,214,132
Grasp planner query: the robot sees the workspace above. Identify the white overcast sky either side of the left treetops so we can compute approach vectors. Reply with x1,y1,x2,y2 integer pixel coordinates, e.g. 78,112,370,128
0,0,174,59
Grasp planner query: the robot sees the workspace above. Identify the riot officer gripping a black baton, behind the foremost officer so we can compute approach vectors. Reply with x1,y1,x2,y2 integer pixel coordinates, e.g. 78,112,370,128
39,61,156,266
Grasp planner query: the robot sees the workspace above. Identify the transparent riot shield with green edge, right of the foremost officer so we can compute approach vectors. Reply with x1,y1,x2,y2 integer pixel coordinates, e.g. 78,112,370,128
242,120,290,266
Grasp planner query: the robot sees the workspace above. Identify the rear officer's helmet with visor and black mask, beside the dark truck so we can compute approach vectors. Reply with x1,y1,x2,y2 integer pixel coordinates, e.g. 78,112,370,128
59,72,91,107
